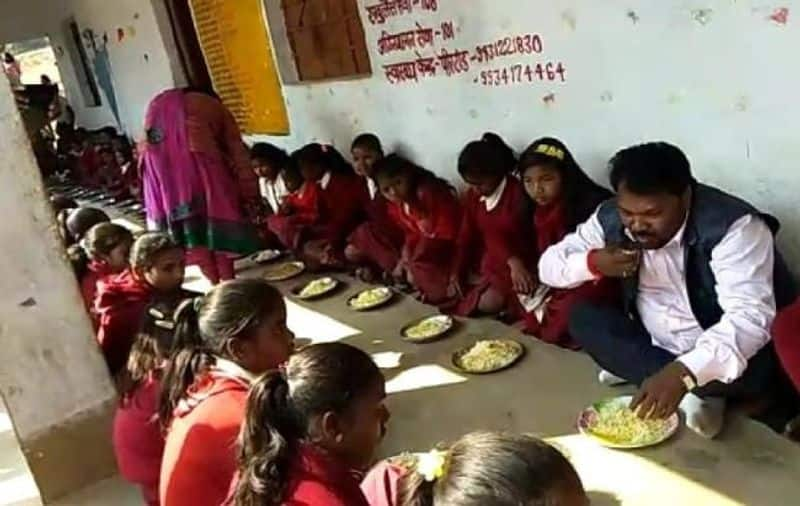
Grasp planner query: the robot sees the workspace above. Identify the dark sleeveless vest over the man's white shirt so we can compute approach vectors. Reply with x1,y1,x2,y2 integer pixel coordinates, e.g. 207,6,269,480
597,184,796,329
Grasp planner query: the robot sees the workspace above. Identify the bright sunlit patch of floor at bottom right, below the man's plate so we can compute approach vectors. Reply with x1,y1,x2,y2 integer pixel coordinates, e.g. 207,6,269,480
547,434,742,506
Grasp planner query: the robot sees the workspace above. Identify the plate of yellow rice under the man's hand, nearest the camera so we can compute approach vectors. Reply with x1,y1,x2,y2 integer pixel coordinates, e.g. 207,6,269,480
578,395,680,450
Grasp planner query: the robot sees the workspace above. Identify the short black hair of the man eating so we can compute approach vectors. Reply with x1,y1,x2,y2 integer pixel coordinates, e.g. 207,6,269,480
609,142,694,195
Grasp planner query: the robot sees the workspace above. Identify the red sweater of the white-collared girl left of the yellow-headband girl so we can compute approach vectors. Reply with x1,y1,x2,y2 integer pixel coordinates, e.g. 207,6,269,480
455,176,536,288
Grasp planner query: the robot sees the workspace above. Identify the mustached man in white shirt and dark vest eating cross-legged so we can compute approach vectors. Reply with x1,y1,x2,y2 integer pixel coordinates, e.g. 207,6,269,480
539,143,794,437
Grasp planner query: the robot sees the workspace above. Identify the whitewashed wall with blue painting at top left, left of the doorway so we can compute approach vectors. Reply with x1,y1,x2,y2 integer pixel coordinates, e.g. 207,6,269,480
0,0,184,136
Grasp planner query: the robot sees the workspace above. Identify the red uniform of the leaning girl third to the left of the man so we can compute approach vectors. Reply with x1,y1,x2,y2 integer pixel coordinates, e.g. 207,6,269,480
389,181,461,304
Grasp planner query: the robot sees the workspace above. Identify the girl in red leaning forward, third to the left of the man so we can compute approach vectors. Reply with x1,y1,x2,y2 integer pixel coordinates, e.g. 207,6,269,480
375,154,461,304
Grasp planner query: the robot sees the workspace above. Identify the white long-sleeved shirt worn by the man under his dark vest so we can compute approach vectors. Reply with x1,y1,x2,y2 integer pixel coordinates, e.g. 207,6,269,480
539,213,775,386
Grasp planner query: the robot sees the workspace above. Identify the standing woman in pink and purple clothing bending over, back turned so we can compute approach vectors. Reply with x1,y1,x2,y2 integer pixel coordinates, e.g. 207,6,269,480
141,89,259,284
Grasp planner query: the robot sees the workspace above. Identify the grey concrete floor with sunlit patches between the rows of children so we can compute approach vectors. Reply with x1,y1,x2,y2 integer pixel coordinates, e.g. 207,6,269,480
0,262,800,506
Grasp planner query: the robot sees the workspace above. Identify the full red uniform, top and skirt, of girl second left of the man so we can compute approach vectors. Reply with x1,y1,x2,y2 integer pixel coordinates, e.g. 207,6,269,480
455,176,536,316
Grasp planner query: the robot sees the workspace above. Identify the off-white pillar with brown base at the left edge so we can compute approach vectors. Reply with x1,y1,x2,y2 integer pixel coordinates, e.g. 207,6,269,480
0,59,117,501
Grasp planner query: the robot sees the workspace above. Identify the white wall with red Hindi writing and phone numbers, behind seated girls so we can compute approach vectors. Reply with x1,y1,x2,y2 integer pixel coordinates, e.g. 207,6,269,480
253,0,800,261
